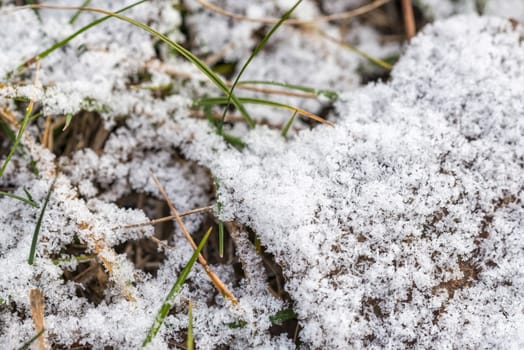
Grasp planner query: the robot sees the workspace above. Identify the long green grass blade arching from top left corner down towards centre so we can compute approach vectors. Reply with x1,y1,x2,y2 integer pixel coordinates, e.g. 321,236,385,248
16,5,255,128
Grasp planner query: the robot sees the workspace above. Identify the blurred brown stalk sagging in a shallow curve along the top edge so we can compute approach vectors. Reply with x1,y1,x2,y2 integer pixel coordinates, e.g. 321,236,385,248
196,0,391,25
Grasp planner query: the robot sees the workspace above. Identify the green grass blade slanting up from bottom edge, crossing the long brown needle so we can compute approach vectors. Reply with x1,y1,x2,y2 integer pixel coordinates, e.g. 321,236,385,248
142,228,211,347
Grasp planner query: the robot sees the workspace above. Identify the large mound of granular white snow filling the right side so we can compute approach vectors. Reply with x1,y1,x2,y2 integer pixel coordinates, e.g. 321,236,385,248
190,17,524,349
